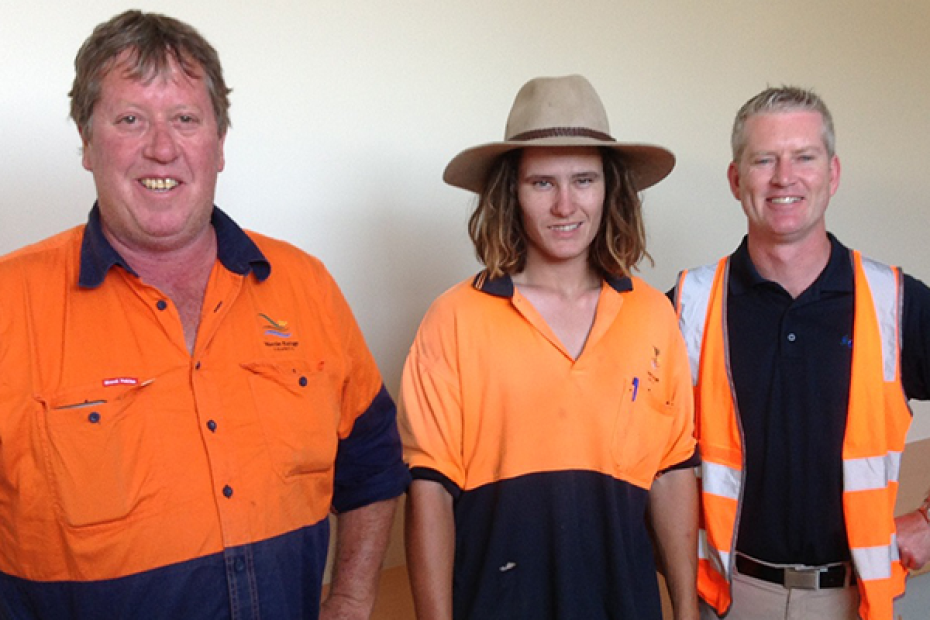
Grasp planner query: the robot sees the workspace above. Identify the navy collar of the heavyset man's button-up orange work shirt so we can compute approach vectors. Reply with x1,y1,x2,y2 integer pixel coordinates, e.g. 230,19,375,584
78,203,271,288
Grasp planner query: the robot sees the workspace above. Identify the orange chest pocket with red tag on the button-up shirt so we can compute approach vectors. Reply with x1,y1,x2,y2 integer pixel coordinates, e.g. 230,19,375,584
39,383,161,527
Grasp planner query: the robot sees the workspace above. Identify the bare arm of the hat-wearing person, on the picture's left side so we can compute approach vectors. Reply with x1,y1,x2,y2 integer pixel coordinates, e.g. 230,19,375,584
405,480,455,620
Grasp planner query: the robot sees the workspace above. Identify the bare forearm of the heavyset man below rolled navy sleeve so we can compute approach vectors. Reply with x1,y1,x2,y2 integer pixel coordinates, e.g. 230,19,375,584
321,499,397,620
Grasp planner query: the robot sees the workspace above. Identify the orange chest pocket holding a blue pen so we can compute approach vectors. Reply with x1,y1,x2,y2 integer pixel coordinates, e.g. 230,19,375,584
612,378,674,489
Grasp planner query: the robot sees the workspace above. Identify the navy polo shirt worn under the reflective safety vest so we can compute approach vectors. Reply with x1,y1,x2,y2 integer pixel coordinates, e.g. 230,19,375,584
727,235,930,565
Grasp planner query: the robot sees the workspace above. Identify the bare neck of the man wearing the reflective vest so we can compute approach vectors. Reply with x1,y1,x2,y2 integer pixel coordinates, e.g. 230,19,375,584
749,232,831,298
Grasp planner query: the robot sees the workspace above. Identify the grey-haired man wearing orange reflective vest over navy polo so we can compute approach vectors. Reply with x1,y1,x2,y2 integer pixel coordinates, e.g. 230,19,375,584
673,87,930,620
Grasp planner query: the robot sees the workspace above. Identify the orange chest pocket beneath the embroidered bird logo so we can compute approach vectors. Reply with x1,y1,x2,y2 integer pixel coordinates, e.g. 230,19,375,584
242,360,341,478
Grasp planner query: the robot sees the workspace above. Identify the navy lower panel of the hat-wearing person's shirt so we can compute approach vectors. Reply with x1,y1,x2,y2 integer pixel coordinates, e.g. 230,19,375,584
452,470,662,620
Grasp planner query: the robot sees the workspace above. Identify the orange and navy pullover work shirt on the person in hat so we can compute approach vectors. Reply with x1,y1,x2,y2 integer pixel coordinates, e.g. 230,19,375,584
400,274,696,620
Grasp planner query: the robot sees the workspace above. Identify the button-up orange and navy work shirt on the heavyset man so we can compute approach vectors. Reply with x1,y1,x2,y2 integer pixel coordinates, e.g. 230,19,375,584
0,207,409,620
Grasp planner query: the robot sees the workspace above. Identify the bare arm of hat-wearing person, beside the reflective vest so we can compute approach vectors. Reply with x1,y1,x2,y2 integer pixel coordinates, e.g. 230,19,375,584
649,469,698,620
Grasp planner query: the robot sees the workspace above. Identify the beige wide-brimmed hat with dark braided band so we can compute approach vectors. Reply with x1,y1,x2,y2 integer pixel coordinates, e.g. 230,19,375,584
442,75,675,194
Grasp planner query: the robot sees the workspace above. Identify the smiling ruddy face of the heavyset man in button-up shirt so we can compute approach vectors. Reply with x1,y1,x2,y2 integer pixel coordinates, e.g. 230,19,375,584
82,54,225,252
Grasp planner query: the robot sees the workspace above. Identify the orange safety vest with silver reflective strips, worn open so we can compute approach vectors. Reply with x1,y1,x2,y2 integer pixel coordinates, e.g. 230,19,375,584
675,251,912,620
